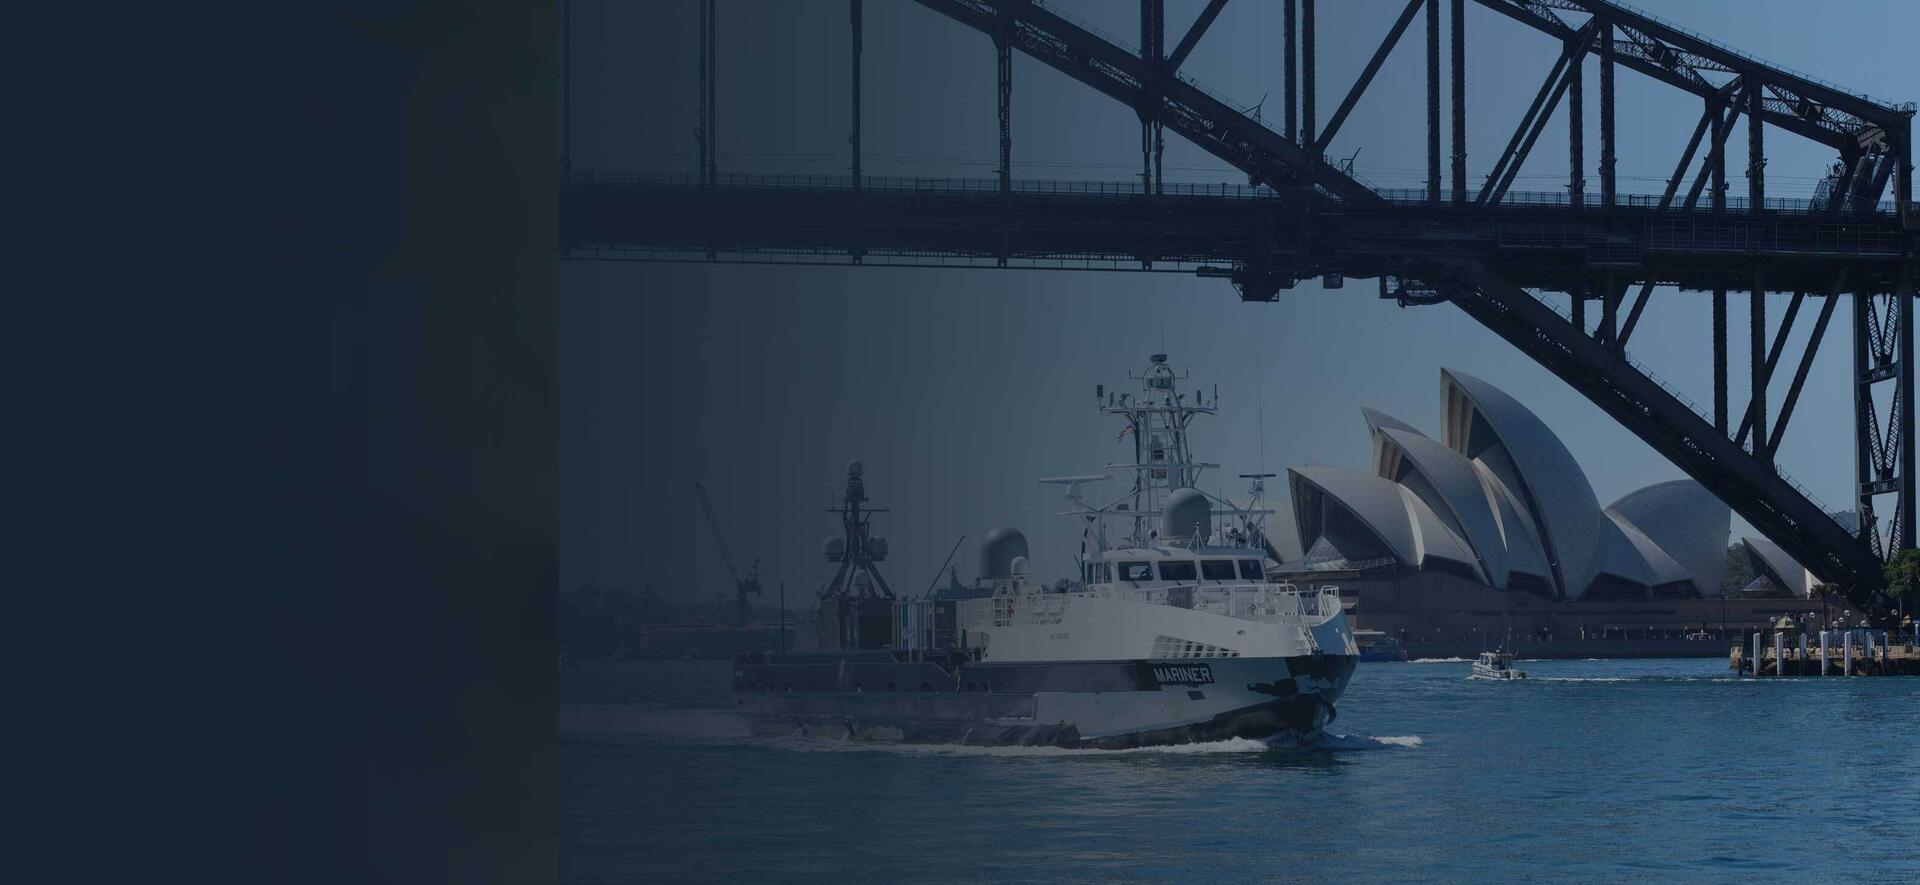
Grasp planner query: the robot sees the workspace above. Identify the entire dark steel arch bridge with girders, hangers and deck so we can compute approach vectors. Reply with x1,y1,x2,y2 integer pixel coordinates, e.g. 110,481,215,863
563,0,1920,610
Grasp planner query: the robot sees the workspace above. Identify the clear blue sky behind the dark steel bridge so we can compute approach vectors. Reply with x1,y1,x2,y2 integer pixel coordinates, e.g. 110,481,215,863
561,0,1920,605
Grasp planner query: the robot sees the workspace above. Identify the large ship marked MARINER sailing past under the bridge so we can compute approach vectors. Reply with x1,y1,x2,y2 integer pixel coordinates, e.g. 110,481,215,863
733,353,1359,749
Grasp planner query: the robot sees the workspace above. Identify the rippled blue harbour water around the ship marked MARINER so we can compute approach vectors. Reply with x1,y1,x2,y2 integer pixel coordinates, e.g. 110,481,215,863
561,658,1920,883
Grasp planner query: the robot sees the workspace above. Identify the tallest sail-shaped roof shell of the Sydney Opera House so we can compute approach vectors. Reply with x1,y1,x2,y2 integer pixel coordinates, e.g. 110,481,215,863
1440,369,1613,599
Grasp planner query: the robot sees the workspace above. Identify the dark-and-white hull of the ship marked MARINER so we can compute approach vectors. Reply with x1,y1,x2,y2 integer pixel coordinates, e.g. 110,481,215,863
735,653,1356,749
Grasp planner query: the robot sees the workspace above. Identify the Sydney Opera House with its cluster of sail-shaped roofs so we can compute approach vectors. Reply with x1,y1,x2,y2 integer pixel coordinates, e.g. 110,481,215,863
1283,371,1816,643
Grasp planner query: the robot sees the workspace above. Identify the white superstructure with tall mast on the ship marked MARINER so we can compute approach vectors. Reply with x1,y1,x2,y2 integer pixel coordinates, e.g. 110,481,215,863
908,353,1359,660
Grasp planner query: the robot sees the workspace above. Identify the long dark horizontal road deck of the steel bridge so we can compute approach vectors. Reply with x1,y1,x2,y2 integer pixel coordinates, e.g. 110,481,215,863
564,173,1914,292
